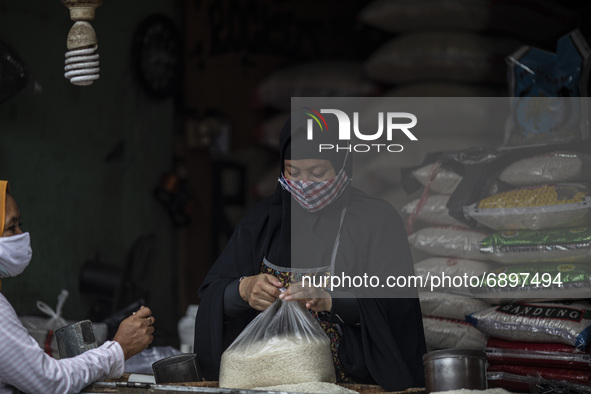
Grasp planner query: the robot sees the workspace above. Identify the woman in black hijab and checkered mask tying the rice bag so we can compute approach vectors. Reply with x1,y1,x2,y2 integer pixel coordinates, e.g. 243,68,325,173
194,115,426,391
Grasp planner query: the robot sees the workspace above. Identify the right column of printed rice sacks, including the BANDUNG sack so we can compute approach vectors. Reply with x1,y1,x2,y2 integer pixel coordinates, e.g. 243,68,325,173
464,151,591,392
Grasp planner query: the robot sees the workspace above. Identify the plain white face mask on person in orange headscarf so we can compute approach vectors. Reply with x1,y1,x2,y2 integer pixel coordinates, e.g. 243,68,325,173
0,233,33,278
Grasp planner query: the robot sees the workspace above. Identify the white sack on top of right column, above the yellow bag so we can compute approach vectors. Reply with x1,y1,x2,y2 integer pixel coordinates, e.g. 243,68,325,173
499,151,591,186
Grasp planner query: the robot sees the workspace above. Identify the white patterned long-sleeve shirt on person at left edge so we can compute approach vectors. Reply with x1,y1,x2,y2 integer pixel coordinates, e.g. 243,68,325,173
0,294,125,394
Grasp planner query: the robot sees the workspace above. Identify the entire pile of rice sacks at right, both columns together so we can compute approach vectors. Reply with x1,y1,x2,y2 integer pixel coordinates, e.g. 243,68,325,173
402,147,591,392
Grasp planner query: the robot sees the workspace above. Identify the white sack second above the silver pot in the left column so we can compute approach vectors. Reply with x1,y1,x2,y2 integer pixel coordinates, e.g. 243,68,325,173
419,291,491,321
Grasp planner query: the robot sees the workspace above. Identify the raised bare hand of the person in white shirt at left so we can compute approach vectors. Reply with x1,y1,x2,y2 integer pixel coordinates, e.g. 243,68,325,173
113,306,155,360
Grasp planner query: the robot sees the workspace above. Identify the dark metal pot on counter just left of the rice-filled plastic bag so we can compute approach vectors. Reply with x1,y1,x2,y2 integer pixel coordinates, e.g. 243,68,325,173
152,353,202,383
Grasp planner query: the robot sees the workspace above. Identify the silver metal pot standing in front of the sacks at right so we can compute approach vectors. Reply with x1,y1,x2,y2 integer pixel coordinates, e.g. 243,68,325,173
423,349,487,393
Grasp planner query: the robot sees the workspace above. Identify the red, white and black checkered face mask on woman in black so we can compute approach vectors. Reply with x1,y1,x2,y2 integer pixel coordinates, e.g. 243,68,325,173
279,168,350,212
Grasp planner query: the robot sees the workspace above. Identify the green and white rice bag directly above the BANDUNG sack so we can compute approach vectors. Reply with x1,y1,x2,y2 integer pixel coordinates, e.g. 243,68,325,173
470,261,591,304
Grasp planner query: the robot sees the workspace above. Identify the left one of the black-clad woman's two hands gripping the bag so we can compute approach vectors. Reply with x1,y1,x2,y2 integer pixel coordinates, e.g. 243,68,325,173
238,274,283,311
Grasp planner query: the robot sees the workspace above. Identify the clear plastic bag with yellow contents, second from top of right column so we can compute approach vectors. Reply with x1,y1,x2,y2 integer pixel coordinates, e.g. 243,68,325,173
464,183,591,230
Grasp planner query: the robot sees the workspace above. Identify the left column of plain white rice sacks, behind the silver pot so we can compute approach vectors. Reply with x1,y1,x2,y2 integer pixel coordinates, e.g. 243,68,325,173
401,154,497,351
